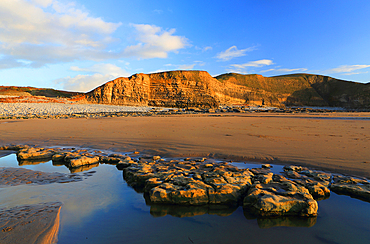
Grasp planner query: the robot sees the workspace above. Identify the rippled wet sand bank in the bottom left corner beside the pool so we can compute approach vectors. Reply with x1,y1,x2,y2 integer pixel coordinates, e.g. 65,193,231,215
0,202,62,244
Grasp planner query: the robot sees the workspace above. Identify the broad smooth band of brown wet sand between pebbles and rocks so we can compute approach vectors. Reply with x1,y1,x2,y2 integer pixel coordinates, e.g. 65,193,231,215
0,113,370,178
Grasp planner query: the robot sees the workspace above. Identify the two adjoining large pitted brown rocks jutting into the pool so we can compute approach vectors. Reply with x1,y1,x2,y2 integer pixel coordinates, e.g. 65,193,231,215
123,159,318,217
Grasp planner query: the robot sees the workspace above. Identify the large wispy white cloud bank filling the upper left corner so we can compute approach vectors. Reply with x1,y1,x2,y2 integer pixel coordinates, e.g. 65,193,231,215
0,0,121,67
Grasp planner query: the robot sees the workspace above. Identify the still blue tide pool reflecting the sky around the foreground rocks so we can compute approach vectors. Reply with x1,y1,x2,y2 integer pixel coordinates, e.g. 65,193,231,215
0,154,370,244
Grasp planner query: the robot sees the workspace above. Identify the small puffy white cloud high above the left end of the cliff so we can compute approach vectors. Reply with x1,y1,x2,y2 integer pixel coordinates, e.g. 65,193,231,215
123,24,188,59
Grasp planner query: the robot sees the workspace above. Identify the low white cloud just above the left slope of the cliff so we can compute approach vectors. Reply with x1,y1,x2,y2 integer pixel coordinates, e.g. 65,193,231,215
54,63,130,92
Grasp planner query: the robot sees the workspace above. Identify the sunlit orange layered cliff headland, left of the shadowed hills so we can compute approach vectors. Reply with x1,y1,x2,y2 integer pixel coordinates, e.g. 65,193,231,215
86,71,219,108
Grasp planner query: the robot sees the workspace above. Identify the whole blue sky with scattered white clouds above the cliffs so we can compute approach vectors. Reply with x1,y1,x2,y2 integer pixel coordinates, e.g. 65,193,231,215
0,0,370,92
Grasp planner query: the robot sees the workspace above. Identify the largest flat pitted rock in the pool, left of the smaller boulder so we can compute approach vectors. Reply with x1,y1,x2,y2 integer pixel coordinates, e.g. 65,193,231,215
123,160,253,205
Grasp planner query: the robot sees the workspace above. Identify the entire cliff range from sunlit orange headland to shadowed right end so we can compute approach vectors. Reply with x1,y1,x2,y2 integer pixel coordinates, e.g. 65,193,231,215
86,71,370,108
